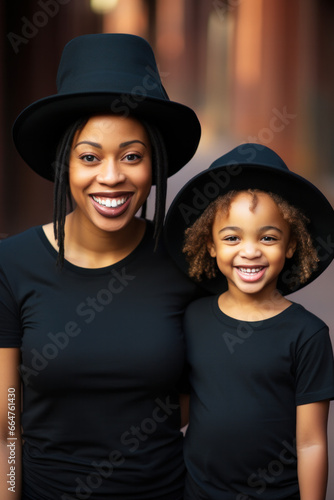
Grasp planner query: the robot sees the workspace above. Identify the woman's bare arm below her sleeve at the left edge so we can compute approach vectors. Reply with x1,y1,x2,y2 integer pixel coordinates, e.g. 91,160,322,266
0,348,22,500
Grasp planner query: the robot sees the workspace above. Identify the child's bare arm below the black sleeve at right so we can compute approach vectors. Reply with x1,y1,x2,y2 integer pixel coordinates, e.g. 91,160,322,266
296,401,329,500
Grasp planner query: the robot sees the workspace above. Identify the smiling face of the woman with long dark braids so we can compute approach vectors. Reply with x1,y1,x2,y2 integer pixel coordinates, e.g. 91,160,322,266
69,115,152,232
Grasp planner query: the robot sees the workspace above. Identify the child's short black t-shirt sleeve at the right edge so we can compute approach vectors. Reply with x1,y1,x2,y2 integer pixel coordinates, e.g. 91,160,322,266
296,326,334,405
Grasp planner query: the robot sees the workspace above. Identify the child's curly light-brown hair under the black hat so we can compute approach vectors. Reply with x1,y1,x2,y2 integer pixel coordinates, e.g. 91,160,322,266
183,189,319,290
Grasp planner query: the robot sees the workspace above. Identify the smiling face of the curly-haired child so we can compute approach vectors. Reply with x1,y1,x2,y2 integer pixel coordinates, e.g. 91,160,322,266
208,192,295,295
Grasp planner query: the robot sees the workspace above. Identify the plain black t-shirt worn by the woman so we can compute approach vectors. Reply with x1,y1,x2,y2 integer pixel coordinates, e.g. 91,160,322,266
0,224,201,500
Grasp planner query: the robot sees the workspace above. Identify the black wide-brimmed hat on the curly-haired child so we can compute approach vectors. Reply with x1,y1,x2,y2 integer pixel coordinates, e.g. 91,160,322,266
164,143,334,295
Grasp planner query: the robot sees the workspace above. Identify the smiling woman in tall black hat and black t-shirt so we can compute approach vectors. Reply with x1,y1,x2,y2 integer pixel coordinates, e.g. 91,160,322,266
0,34,200,500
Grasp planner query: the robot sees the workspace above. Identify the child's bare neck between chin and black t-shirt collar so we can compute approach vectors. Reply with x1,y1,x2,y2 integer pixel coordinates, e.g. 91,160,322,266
218,290,291,321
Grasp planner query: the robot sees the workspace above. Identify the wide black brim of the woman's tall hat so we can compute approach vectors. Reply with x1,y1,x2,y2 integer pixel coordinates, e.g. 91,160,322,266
13,92,201,181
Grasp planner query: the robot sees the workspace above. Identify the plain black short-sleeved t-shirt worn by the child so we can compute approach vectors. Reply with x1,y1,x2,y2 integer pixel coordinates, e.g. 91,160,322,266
184,296,334,500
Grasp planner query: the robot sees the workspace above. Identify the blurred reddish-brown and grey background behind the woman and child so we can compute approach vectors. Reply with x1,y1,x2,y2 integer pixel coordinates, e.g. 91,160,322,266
0,0,334,500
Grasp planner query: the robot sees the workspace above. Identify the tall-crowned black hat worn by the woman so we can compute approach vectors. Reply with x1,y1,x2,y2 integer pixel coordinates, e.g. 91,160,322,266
13,33,201,180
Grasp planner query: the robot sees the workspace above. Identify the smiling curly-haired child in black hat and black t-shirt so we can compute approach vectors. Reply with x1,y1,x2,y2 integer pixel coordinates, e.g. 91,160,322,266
165,144,334,500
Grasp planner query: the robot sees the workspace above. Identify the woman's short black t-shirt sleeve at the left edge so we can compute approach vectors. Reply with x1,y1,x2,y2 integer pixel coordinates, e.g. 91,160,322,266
0,267,21,348
